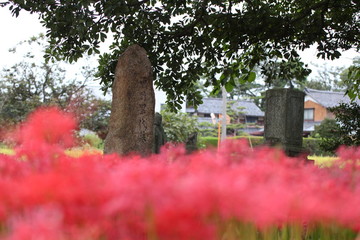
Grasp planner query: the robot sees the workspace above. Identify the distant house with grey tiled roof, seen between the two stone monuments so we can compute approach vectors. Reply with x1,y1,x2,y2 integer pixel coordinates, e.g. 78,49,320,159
186,98,265,133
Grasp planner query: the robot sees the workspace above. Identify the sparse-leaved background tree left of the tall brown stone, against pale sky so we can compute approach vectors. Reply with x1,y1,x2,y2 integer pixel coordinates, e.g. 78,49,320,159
0,35,110,137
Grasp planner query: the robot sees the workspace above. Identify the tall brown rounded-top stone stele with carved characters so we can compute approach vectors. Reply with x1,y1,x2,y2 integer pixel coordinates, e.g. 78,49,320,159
104,45,155,156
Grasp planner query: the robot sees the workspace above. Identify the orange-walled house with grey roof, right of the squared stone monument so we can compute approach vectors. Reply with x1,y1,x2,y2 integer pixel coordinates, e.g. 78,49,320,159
304,88,359,132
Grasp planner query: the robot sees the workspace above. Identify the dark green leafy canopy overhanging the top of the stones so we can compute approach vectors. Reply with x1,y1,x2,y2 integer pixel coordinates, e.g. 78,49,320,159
2,0,360,110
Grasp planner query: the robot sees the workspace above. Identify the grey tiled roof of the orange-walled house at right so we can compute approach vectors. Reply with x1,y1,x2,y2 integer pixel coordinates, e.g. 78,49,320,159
305,88,360,108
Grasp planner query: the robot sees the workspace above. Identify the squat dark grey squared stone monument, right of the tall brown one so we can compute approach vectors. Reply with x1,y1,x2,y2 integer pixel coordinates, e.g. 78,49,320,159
264,88,305,157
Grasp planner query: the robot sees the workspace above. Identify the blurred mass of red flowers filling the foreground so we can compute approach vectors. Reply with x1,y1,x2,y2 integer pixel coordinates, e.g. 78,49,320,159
0,108,360,240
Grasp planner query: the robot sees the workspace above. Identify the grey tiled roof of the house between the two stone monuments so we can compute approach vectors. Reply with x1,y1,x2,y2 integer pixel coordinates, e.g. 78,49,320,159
191,98,265,117
